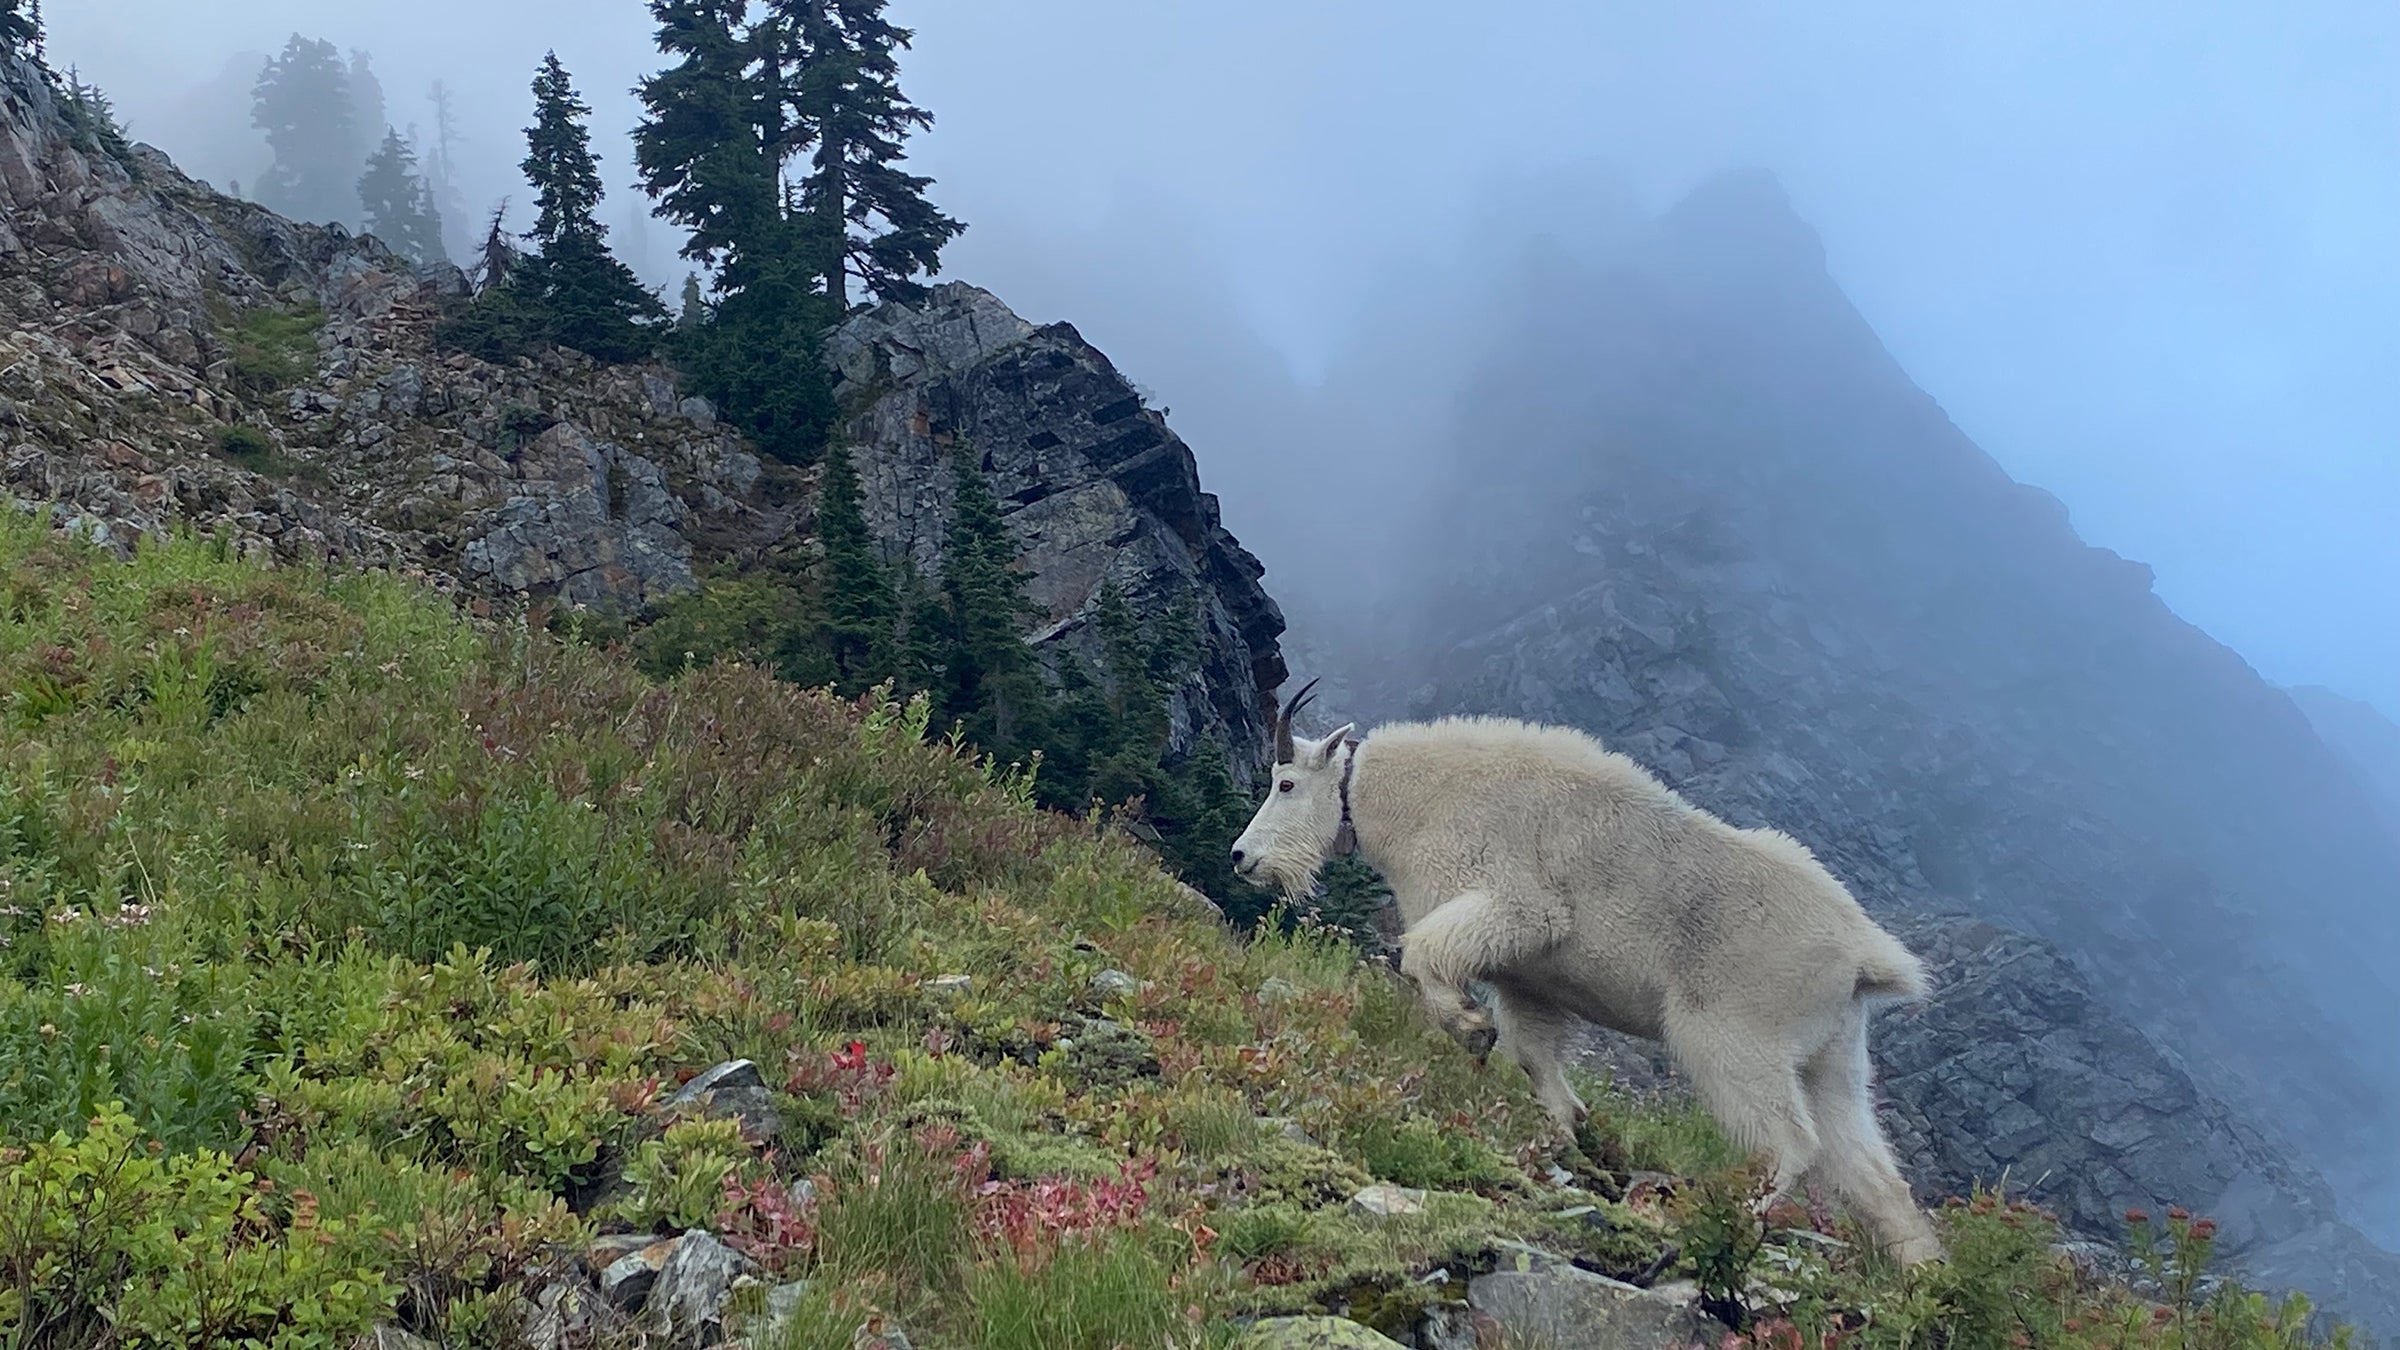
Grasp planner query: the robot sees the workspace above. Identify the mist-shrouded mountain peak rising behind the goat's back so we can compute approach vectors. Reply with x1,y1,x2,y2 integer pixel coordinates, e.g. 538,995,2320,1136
1286,178,2400,1333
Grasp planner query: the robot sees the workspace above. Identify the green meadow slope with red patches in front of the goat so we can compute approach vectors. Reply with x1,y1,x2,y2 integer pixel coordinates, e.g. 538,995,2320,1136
0,512,2361,1350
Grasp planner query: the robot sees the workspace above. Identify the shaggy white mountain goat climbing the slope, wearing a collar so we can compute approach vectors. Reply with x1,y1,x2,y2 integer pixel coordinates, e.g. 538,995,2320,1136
1234,682,1942,1264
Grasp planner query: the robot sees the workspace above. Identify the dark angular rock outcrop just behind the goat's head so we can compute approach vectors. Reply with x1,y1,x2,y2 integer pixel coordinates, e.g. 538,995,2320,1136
828,281,1284,790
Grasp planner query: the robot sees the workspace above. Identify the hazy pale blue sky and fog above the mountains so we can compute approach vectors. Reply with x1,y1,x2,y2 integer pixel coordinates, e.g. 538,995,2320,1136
48,0,2400,713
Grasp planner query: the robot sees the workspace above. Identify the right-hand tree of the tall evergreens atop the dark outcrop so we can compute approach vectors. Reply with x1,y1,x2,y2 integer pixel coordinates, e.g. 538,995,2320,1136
766,0,965,312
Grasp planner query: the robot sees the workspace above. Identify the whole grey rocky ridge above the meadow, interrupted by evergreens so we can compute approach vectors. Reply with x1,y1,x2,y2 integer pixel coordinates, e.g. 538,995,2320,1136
0,58,1282,783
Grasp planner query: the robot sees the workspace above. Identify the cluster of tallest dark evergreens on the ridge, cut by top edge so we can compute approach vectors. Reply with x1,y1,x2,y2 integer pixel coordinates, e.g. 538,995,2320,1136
634,0,962,464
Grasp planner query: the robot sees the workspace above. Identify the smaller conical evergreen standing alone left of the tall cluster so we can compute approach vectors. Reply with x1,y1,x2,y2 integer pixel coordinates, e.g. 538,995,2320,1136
516,53,667,360
